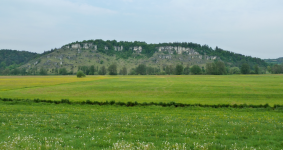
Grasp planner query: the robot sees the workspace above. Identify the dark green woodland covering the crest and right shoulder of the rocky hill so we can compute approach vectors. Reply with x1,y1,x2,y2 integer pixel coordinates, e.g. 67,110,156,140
63,39,267,67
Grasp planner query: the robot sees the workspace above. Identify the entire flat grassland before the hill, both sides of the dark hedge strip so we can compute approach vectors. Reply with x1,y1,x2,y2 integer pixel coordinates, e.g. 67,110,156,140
0,75,283,150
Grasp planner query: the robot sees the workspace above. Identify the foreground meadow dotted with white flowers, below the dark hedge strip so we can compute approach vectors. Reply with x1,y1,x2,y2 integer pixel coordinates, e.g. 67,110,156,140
0,101,283,149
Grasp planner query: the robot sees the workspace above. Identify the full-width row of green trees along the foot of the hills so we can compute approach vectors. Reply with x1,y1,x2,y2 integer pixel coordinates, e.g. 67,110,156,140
0,61,283,75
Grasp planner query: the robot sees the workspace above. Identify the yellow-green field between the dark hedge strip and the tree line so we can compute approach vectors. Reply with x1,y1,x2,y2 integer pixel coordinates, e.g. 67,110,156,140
0,75,283,105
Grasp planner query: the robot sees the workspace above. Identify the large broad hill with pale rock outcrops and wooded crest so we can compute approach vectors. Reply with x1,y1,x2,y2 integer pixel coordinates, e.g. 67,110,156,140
22,40,267,73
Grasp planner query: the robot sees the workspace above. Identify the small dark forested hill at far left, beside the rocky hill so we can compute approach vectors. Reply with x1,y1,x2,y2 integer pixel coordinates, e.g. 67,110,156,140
0,49,39,69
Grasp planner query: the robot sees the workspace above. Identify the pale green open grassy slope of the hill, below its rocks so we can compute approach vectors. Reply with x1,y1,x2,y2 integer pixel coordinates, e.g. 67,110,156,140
22,49,212,74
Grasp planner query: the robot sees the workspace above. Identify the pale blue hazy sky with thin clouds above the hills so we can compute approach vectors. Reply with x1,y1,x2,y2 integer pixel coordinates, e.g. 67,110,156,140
0,0,283,59
